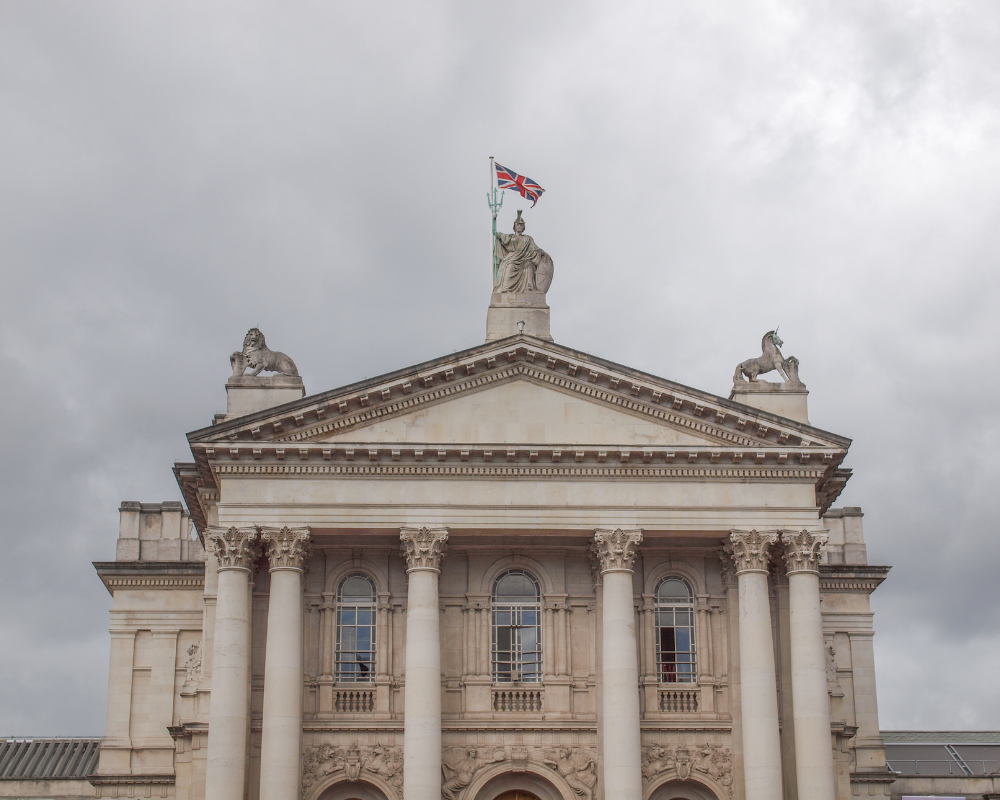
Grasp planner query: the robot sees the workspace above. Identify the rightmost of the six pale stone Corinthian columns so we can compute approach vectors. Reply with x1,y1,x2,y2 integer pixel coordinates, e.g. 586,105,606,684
781,531,836,800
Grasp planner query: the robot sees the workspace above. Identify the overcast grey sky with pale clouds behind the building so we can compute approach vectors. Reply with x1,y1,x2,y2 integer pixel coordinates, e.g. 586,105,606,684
0,0,1000,736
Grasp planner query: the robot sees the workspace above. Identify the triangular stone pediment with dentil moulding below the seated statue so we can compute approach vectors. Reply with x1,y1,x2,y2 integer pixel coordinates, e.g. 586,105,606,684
189,336,850,449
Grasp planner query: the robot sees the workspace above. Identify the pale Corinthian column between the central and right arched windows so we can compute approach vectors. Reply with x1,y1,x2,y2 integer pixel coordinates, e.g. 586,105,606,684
591,528,642,800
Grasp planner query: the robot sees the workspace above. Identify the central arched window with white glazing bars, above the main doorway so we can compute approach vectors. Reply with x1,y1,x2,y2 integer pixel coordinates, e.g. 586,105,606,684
493,569,542,683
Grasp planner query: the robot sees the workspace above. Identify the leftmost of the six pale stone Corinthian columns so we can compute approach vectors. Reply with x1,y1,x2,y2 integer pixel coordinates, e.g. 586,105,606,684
205,528,260,800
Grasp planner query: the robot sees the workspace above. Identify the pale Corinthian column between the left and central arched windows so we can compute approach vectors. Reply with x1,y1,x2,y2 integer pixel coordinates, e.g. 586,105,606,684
399,528,448,800
